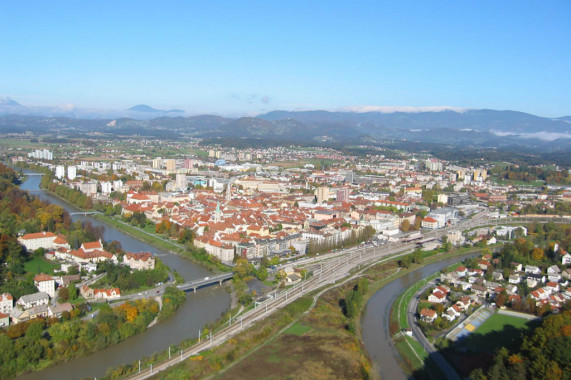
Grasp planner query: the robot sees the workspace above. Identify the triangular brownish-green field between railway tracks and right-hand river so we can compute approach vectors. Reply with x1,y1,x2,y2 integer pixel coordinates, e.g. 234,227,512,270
215,281,369,380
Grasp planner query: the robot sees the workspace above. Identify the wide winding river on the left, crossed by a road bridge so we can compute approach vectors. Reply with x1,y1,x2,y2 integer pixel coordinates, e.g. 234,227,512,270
17,176,231,380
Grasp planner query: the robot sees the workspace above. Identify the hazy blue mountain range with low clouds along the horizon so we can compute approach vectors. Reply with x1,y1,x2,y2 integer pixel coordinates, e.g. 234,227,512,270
0,98,571,151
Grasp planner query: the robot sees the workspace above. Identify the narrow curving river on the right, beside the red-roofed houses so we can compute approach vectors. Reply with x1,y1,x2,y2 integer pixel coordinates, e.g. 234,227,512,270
361,253,474,380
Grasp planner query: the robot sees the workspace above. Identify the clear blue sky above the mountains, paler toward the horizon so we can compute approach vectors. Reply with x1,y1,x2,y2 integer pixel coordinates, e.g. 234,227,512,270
0,0,571,117
